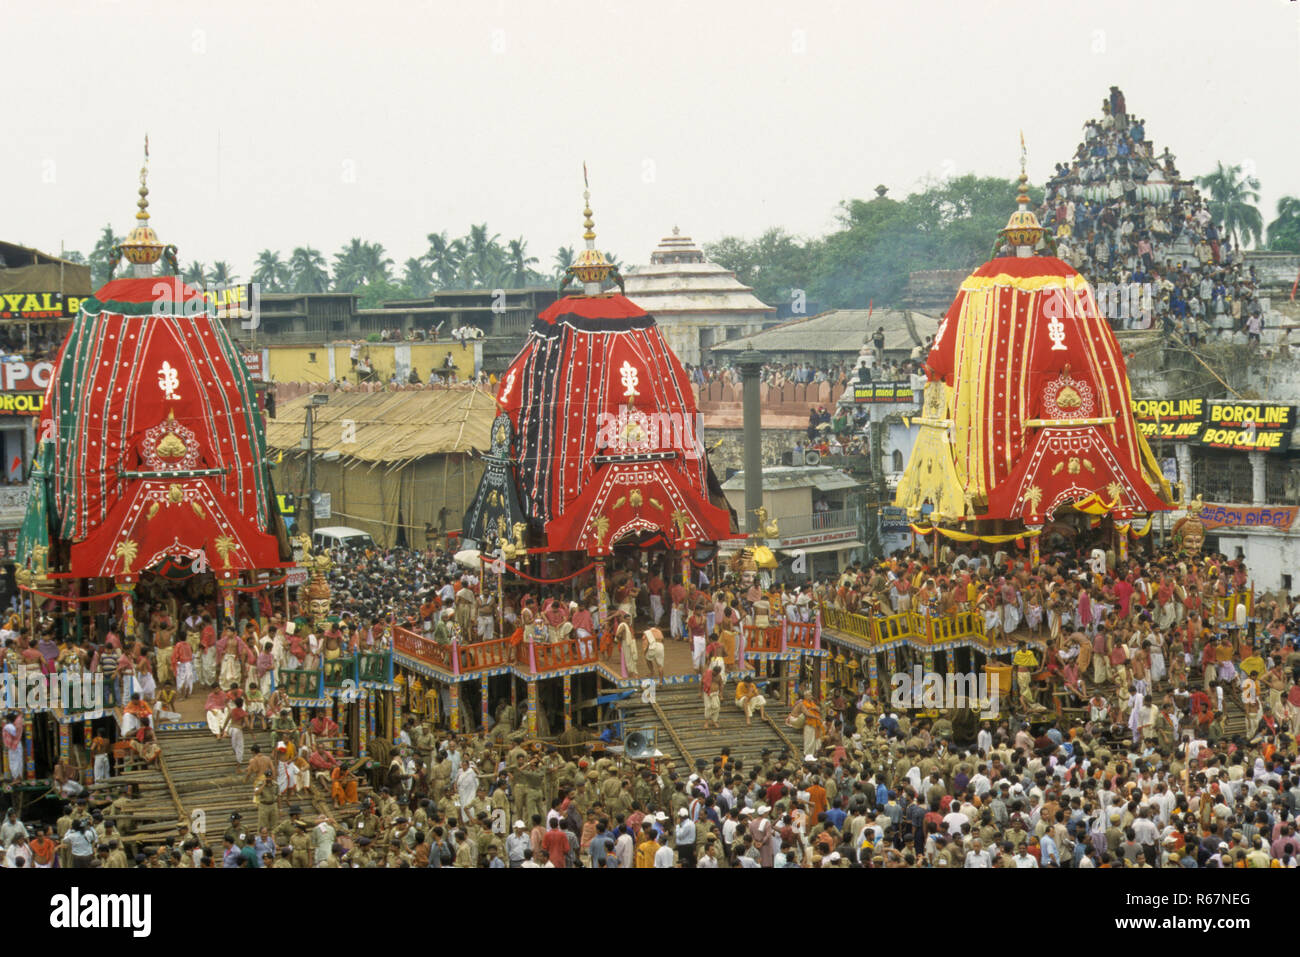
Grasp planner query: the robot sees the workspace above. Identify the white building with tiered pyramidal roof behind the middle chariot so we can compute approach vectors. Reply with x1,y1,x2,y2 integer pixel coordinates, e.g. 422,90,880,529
625,226,776,365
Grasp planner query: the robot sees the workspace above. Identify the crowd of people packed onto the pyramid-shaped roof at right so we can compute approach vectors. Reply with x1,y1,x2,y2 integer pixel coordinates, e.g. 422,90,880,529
1039,87,1264,346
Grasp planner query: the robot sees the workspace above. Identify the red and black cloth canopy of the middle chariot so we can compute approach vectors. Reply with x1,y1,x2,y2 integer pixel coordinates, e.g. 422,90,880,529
486,294,732,555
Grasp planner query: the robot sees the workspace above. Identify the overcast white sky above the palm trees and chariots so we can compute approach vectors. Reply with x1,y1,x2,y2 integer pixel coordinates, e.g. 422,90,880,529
0,0,1300,278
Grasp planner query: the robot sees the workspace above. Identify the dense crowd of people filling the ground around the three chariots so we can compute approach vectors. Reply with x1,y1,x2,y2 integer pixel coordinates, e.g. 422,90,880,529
0,527,1300,869
